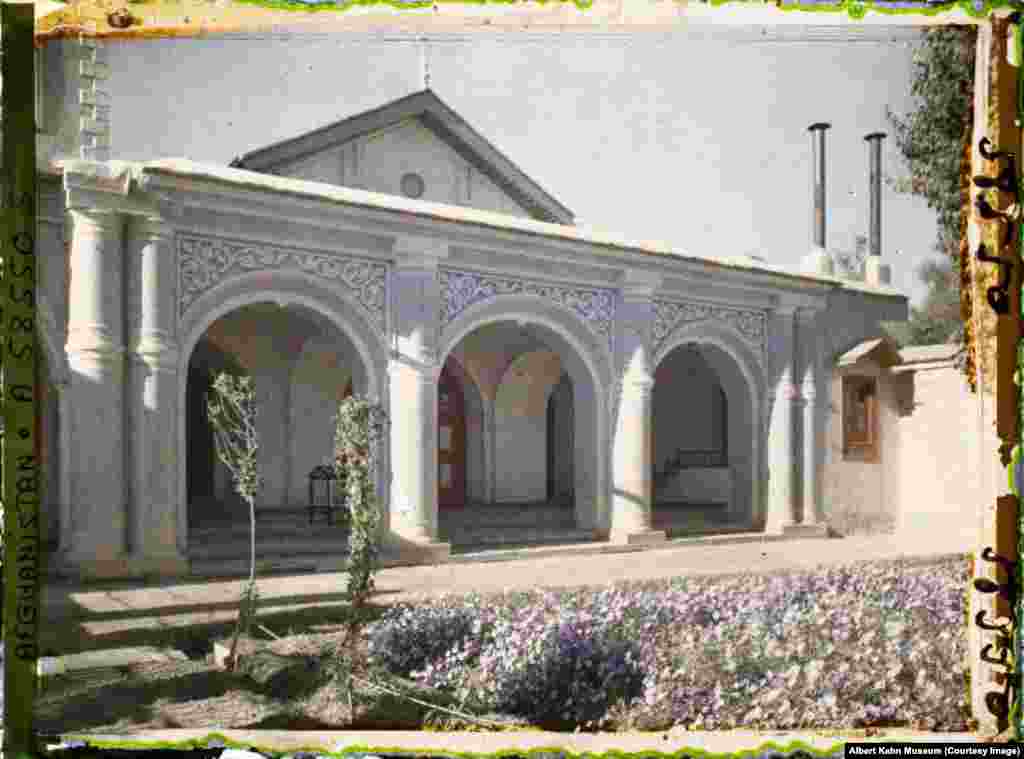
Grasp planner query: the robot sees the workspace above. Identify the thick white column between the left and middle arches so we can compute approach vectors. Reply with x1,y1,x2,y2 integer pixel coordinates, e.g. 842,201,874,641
388,239,451,560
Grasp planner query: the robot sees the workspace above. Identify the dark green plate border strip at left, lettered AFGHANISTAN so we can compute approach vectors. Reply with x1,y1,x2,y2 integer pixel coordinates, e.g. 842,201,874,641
0,3,40,758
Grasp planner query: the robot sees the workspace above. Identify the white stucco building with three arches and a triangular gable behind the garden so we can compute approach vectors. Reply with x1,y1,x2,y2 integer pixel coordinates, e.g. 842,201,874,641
22,31,999,577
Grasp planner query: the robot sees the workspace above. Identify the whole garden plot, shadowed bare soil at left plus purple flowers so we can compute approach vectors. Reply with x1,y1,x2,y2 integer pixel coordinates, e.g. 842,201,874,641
37,556,972,733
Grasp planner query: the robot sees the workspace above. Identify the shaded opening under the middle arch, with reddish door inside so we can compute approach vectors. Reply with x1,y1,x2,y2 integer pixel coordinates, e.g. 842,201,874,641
437,320,600,544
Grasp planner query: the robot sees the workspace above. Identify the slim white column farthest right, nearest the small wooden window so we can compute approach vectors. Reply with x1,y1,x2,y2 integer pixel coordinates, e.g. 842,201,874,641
796,308,827,537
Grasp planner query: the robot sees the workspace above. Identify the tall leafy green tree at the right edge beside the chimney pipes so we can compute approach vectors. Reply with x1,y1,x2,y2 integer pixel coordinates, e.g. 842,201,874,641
887,26,976,345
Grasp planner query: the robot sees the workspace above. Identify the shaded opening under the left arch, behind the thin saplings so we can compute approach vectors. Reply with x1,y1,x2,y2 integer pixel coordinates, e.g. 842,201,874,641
184,302,369,542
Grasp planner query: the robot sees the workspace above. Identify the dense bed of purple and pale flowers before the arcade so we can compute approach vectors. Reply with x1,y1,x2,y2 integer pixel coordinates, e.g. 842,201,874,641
368,557,970,730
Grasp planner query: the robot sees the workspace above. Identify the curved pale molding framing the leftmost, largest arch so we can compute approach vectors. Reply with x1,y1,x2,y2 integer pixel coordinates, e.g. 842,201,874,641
177,270,389,553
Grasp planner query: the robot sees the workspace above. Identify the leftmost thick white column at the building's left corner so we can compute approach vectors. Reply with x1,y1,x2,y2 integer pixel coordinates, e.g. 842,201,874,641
61,210,127,577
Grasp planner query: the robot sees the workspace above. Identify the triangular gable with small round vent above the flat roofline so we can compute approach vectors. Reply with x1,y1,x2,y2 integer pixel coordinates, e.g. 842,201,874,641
231,89,573,224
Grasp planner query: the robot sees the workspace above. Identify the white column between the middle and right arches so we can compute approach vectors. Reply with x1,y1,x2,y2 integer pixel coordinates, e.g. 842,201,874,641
609,280,666,543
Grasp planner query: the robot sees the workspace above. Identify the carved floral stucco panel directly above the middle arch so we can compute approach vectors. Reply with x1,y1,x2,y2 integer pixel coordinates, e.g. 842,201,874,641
439,268,615,346
